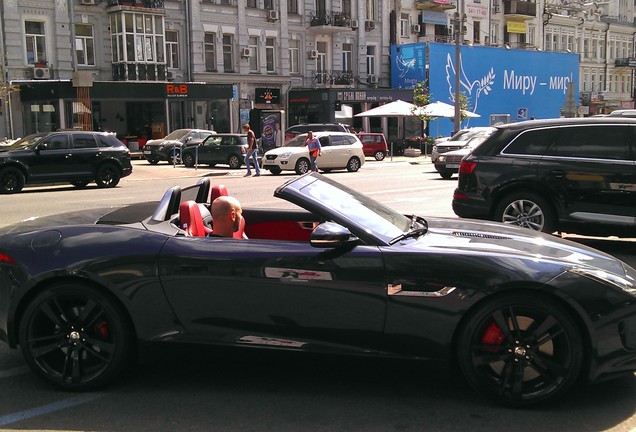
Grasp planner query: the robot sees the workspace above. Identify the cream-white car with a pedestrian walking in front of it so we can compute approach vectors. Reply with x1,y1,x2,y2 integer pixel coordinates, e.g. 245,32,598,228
263,132,364,175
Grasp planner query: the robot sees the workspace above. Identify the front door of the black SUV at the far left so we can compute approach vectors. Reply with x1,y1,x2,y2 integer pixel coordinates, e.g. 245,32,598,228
27,133,74,182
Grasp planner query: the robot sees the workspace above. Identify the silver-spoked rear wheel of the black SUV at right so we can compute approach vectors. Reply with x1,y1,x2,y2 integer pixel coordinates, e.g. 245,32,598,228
495,192,556,233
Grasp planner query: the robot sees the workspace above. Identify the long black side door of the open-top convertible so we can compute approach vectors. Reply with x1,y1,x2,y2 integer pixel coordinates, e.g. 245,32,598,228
159,237,386,349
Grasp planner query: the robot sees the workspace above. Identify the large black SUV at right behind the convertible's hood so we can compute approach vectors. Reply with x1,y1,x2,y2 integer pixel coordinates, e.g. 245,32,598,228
453,117,636,235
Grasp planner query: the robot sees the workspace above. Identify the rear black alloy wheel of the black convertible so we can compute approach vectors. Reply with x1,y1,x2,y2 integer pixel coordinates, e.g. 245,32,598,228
20,282,135,390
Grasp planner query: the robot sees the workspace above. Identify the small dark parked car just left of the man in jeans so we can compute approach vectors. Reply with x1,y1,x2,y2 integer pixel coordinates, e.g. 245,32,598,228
183,133,247,169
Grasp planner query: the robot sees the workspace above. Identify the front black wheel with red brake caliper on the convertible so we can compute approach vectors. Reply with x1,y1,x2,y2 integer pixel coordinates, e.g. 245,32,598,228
457,293,585,407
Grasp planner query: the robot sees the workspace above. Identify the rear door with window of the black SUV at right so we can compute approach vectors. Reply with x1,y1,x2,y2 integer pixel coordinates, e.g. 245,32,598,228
539,124,636,226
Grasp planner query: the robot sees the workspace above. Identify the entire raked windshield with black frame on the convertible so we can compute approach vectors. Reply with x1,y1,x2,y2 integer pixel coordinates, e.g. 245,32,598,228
274,173,411,246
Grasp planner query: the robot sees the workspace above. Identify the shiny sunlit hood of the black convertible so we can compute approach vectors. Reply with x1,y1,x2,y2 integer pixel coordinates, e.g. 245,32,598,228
418,218,625,274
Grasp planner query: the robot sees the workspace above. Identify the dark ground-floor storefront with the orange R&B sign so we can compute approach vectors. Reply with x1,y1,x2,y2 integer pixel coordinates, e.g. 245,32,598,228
13,80,233,139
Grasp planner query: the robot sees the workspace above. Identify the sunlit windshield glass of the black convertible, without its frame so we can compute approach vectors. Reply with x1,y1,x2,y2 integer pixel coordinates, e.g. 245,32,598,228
284,174,411,243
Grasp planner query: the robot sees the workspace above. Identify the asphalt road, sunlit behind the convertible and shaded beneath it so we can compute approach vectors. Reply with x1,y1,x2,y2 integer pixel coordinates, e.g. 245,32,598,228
0,158,636,432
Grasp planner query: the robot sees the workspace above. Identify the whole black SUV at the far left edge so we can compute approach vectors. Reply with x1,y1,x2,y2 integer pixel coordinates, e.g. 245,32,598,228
0,131,132,194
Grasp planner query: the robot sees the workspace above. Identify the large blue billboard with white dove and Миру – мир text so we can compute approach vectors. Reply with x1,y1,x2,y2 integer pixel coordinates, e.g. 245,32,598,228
391,42,579,135
